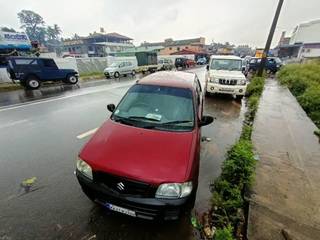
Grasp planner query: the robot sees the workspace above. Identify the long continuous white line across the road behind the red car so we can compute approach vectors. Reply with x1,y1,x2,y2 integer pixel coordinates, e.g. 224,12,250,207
0,82,133,112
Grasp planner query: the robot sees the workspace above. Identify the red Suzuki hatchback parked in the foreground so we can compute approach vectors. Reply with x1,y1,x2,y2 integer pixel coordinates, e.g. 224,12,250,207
76,72,213,220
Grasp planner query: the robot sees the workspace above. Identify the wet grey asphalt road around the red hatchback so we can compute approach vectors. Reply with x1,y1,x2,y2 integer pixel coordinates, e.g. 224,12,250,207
0,68,244,240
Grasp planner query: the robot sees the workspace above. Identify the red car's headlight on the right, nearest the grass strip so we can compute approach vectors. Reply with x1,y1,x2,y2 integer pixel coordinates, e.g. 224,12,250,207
156,182,192,199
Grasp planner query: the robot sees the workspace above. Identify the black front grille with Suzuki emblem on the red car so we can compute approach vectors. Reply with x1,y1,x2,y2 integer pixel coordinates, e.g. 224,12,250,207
93,172,157,198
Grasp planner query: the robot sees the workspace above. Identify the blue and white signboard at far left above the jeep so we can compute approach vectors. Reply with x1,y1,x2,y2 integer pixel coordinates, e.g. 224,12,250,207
0,31,31,50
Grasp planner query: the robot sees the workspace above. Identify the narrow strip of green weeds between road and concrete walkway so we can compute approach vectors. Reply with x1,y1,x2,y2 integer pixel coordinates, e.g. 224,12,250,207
211,77,265,239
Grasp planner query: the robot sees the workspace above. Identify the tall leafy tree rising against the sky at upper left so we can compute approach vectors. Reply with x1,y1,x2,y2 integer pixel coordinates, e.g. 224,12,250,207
18,10,46,43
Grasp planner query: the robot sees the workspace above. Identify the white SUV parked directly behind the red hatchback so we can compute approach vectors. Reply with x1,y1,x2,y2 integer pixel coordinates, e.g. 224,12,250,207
205,55,247,99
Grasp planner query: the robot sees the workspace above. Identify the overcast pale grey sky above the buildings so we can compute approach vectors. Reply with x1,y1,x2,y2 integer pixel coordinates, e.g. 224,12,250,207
0,0,320,47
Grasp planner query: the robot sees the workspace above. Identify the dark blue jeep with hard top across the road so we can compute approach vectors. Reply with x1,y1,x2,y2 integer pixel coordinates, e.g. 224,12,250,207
7,57,79,89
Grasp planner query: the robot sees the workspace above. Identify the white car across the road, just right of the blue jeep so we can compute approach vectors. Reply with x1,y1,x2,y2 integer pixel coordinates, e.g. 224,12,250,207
103,61,137,78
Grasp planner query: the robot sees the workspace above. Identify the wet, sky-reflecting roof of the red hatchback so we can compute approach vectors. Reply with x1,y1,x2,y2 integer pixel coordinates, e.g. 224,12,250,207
138,71,196,90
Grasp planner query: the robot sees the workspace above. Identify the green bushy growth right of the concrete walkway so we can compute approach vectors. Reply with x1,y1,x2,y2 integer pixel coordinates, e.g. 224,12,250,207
277,61,320,128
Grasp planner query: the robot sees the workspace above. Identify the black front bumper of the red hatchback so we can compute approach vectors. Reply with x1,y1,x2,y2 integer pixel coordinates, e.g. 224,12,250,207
76,171,192,220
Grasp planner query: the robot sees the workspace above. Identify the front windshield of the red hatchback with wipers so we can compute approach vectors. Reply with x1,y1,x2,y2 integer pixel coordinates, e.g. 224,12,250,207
112,84,194,131
